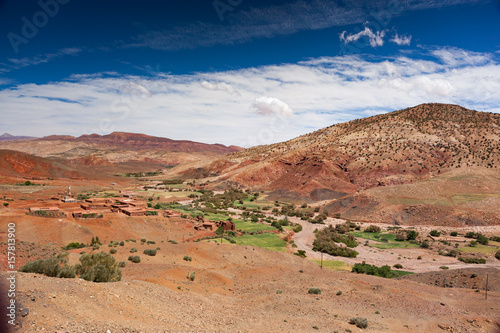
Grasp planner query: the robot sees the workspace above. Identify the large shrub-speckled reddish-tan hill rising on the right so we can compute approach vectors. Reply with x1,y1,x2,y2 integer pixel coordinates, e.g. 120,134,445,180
179,104,500,223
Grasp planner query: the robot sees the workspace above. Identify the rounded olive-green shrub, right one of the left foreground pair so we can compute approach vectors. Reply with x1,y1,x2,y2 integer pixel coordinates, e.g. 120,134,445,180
76,252,122,282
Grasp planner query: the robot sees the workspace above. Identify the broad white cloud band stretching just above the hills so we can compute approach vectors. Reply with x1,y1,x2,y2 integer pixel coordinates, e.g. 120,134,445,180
0,49,500,146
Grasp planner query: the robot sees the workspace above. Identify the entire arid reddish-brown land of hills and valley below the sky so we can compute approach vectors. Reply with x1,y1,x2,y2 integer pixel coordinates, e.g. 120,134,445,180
0,104,500,333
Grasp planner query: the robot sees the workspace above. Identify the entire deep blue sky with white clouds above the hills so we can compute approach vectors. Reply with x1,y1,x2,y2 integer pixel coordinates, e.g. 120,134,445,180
0,0,500,147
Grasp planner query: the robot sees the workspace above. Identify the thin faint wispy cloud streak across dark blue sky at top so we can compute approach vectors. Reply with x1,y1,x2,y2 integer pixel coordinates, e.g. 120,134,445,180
124,0,482,51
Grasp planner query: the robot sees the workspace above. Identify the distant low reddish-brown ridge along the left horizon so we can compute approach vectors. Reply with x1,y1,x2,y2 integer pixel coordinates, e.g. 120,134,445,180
0,132,241,166
